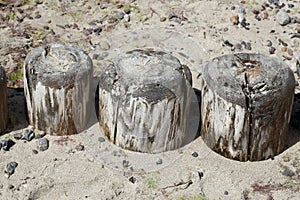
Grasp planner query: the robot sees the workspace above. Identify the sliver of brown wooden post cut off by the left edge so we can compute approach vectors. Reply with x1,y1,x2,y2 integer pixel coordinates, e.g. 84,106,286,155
0,66,8,133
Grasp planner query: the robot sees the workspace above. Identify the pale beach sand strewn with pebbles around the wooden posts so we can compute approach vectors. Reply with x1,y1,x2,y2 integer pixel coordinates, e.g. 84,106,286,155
0,0,300,200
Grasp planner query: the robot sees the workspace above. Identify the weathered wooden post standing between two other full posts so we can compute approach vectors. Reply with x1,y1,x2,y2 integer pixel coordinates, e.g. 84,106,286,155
98,50,192,153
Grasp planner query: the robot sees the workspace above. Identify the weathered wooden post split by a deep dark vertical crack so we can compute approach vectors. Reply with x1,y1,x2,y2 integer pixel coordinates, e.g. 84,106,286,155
201,53,295,161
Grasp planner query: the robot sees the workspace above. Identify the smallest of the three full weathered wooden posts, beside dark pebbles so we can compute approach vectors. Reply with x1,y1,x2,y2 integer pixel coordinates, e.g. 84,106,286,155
24,44,93,135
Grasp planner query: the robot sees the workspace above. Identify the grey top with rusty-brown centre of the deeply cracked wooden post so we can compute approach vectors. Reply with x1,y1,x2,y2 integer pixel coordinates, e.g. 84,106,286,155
202,53,295,108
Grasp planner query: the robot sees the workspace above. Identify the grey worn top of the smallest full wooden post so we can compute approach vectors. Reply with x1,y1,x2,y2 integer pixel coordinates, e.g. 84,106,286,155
25,44,92,89
